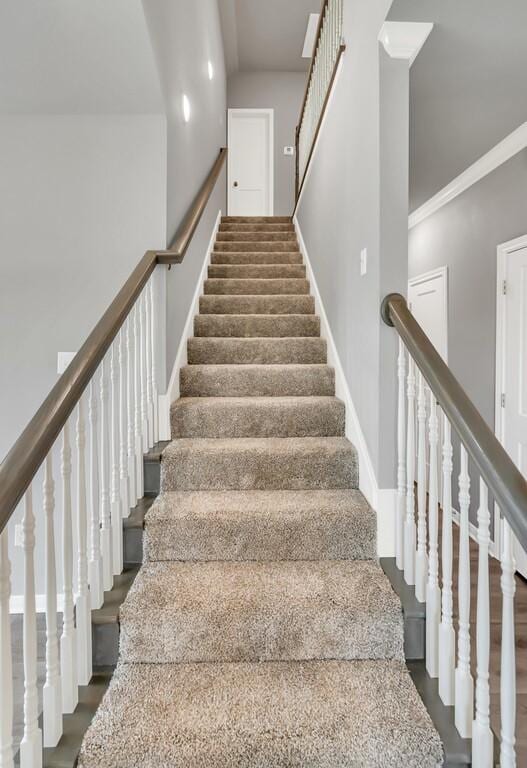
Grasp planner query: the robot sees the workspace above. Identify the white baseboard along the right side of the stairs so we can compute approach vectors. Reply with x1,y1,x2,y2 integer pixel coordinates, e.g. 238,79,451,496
293,215,397,557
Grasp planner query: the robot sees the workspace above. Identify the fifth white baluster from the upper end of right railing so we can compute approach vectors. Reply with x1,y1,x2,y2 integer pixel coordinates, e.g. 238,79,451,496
439,414,455,706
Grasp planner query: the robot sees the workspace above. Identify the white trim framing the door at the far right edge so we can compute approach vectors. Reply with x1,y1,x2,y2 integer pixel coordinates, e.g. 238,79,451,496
494,234,527,559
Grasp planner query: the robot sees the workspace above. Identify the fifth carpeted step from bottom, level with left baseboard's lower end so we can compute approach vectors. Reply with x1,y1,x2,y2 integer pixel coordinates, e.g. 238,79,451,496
170,397,346,439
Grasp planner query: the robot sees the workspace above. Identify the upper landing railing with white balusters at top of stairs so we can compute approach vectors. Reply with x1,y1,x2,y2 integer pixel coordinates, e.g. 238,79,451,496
295,0,346,200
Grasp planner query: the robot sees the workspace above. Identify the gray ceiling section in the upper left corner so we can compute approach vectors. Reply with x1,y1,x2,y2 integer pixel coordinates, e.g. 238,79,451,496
0,0,163,114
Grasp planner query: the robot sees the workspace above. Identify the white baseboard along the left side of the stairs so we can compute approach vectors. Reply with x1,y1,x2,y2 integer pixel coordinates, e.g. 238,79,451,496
159,210,222,440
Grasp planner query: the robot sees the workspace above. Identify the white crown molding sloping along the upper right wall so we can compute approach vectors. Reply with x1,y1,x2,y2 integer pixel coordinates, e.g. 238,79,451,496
408,122,527,229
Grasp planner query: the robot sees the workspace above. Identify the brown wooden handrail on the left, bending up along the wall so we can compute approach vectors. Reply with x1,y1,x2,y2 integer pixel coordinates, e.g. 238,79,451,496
0,148,227,532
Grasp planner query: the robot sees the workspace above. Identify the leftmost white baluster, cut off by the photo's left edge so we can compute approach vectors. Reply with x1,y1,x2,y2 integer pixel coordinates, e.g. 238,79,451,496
0,528,14,768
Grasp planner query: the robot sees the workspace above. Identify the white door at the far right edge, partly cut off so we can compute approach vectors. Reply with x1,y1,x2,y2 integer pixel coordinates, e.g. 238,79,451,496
498,238,527,577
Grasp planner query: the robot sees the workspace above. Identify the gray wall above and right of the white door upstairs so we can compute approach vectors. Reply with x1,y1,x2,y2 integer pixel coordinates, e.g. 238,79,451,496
227,72,307,216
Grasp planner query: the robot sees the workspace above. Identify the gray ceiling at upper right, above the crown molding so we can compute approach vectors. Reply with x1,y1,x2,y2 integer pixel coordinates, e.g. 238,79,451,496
388,0,527,210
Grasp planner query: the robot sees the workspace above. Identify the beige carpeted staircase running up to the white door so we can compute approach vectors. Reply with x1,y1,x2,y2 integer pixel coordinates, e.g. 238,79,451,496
79,217,443,768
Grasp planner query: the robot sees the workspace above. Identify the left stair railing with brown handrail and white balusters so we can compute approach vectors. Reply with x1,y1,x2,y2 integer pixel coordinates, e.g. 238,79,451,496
0,149,227,768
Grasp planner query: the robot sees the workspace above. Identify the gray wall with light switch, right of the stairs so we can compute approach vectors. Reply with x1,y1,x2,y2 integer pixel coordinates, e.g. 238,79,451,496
298,0,408,488
